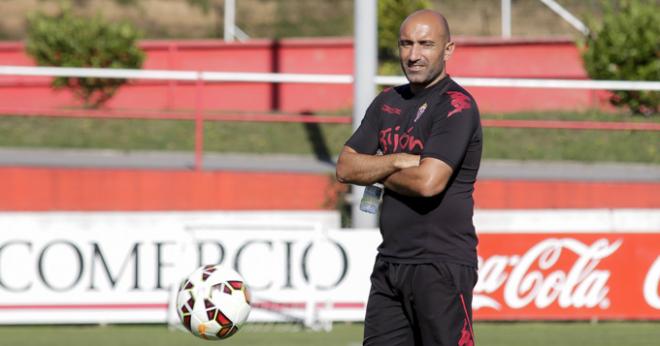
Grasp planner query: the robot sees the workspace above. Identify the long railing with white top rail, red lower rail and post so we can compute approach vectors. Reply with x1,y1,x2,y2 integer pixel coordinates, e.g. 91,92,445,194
0,66,660,170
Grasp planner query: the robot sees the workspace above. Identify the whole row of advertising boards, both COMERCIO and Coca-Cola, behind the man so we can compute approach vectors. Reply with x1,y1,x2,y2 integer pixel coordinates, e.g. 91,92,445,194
0,210,660,324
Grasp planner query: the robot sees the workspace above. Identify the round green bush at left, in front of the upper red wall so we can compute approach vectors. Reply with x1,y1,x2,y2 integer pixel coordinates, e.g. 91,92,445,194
26,7,145,108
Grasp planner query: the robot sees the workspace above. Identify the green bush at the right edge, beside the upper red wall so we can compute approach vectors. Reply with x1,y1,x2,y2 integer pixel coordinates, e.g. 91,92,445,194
583,0,660,115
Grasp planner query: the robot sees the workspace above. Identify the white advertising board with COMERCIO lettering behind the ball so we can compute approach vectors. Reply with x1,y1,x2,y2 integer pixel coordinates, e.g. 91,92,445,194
0,213,379,324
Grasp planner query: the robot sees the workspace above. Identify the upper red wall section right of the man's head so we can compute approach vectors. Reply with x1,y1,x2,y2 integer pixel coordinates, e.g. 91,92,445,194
448,39,607,113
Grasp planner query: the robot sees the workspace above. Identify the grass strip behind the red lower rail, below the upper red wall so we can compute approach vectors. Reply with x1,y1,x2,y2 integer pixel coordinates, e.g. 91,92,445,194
0,112,660,164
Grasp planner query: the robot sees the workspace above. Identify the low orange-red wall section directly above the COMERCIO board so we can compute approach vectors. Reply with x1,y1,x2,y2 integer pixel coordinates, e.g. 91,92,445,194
0,167,342,211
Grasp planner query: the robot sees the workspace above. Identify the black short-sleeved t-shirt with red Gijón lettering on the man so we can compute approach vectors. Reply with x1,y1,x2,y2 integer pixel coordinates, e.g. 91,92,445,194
346,77,483,267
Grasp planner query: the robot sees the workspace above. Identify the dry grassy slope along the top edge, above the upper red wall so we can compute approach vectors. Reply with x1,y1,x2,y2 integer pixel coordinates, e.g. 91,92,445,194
1,0,616,40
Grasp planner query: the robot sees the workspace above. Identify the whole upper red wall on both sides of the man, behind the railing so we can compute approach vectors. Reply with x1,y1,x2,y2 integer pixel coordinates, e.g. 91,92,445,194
0,38,604,114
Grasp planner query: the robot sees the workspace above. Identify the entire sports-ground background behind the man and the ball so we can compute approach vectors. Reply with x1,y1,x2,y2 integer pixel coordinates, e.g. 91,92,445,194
0,0,660,345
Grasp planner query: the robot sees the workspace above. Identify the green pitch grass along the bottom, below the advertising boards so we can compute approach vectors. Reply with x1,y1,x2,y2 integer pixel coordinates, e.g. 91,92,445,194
0,322,660,346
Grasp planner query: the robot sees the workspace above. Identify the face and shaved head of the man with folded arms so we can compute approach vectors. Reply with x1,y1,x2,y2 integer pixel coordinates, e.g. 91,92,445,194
399,19,454,88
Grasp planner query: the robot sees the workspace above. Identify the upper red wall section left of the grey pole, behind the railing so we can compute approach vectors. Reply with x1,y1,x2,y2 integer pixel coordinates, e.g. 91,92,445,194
0,39,353,112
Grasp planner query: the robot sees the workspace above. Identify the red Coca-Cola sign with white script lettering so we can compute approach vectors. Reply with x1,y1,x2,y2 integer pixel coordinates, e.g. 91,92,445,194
473,233,660,320
